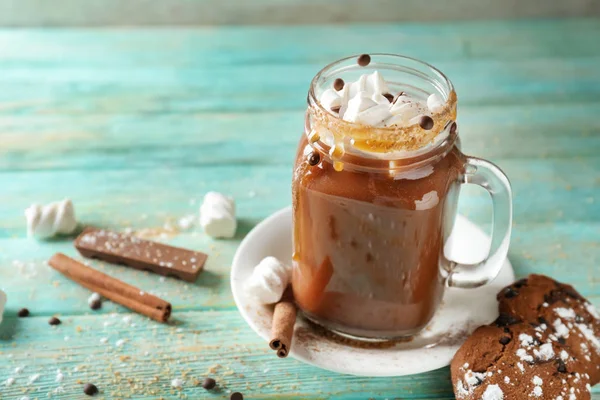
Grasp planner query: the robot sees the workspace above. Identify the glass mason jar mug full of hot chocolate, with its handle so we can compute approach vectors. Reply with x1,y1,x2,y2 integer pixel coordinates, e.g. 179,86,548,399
292,55,512,340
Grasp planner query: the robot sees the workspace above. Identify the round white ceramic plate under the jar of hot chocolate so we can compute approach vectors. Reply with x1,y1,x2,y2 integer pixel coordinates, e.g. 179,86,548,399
231,207,514,376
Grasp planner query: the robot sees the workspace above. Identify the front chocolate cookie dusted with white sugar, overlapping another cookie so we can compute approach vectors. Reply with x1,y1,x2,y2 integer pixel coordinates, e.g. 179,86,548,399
451,322,591,400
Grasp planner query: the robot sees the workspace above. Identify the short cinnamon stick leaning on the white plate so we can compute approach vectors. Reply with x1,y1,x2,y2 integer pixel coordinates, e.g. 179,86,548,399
269,287,297,358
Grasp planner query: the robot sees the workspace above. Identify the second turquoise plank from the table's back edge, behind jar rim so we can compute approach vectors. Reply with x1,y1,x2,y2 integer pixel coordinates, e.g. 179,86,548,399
0,57,600,115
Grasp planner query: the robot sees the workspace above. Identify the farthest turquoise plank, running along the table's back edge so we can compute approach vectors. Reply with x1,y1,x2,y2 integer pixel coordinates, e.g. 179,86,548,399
0,19,600,68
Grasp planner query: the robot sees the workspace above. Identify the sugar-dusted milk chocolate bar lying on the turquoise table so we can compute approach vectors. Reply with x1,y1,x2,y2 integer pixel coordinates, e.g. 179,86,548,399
75,229,208,282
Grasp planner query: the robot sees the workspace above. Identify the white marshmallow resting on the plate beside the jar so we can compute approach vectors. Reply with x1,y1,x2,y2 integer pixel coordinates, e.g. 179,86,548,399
245,257,292,304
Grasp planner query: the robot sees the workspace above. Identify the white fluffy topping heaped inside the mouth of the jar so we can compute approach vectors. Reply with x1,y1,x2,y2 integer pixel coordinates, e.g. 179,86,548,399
319,71,445,129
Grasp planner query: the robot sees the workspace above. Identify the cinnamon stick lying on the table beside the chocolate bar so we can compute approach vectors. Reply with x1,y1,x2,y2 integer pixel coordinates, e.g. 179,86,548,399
48,253,171,322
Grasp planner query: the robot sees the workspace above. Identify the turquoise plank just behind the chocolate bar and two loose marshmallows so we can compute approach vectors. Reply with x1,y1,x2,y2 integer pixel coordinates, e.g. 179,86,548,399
0,158,600,238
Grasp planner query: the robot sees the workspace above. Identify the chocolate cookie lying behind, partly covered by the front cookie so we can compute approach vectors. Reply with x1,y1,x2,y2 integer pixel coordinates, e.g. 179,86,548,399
498,275,600,385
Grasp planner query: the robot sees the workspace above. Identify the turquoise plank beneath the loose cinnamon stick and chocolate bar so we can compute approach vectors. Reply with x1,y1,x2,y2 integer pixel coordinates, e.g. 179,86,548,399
0,222,600,317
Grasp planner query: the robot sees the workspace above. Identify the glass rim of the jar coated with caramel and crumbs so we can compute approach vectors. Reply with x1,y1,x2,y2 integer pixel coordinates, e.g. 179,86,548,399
307,53,456,157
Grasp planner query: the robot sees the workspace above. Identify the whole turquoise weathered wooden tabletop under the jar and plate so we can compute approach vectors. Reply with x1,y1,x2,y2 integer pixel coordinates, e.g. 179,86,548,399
0,20,600,399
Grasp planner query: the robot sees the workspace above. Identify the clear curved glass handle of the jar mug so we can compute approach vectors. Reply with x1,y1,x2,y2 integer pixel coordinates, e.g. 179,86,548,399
447,157,512,288
